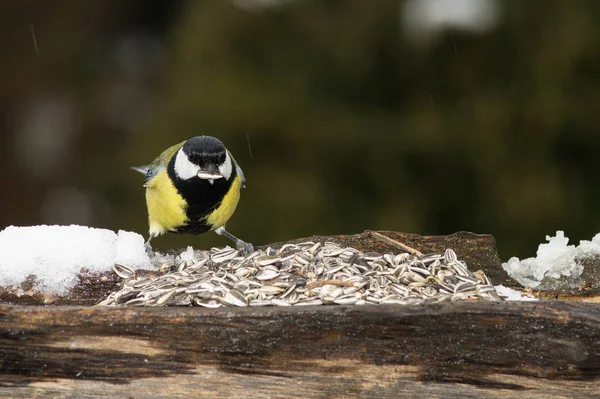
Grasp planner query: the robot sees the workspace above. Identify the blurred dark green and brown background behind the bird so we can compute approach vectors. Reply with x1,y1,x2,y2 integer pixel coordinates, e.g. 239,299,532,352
0,0,600,260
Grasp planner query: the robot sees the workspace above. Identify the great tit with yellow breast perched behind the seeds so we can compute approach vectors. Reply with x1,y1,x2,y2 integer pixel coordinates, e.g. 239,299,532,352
133,136,254,252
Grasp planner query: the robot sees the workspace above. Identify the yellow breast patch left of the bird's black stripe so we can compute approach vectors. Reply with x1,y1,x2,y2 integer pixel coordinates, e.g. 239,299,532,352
146,169,188,236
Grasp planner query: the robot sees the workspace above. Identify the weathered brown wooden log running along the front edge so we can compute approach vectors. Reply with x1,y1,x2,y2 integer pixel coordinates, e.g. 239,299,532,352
0,302,600,399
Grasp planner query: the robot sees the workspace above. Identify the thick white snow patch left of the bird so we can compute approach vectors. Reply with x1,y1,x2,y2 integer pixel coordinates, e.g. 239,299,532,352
0,225,150,295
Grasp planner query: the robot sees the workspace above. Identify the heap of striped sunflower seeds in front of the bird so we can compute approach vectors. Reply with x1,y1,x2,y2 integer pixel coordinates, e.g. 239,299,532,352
99,242,501,308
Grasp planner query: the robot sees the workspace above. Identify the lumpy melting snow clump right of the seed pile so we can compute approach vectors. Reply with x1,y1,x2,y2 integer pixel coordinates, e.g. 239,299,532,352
502,231,600,289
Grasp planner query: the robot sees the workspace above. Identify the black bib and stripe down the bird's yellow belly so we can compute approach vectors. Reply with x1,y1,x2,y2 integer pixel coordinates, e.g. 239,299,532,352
167,157,237,234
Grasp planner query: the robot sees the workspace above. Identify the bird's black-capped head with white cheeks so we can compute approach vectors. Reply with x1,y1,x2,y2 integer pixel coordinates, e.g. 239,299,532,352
174,136,233,182
